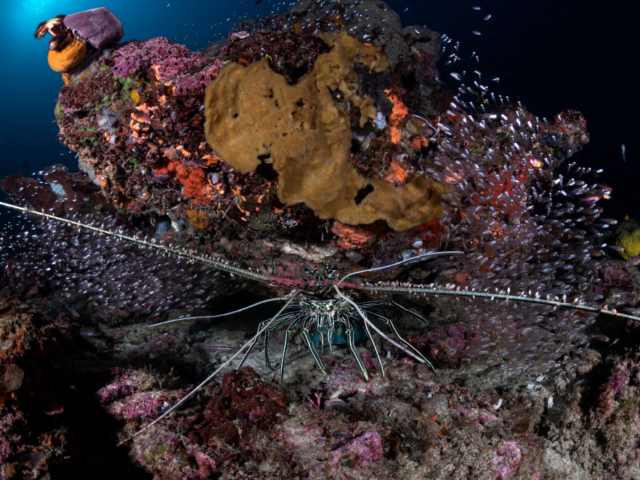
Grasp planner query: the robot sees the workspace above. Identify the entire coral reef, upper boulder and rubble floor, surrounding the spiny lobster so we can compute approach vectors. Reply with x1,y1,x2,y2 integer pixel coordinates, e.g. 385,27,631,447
0,0,640,479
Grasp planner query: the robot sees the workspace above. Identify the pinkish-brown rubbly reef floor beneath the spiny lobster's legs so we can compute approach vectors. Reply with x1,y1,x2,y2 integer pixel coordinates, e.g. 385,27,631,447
0,261,640,479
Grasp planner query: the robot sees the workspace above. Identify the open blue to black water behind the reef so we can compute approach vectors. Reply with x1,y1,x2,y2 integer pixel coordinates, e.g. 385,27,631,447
0,0,640,219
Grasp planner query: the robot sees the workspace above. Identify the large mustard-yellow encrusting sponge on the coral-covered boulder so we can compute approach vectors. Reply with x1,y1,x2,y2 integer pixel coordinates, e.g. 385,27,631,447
205,32,448,231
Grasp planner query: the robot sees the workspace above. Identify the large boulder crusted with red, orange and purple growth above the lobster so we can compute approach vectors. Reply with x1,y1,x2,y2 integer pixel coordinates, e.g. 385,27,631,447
28,2,598,304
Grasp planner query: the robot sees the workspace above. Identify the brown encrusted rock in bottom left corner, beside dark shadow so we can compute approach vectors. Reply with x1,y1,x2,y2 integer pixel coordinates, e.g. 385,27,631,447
0,297,75,479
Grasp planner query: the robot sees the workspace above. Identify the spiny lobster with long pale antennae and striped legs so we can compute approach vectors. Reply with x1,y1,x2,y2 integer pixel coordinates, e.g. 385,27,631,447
0,202,640,441
